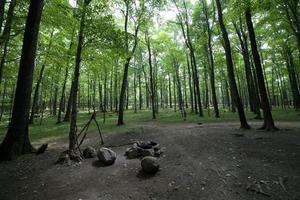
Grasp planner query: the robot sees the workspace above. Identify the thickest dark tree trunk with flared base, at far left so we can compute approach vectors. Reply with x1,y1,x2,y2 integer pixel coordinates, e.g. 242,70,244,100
0,0,44,160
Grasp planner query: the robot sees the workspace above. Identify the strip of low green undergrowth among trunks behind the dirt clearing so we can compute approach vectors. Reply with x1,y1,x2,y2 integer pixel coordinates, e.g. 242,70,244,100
0,109,300,141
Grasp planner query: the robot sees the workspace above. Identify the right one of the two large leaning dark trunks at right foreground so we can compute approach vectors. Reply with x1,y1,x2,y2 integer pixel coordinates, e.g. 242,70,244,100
245,8,277,131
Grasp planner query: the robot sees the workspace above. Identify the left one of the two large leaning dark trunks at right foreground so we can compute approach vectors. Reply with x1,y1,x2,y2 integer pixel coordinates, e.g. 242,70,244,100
216,0,250,129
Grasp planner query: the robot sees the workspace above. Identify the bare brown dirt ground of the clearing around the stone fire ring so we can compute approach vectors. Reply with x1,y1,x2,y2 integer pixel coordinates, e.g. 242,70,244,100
0,122,300,200
